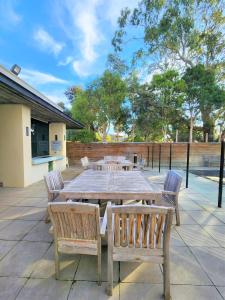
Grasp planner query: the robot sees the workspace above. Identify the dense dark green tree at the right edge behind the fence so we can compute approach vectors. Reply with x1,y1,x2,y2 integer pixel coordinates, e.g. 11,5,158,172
183,64,225,141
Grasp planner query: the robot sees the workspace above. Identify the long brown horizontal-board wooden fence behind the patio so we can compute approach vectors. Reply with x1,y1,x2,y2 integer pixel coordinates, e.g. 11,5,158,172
67,142,220,168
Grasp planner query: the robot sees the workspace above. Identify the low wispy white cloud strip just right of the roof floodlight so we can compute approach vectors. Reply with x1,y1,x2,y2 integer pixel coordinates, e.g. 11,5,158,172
20,69,69,87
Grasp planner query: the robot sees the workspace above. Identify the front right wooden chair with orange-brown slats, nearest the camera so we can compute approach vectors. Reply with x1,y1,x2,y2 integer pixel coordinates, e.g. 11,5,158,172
107,204,174,300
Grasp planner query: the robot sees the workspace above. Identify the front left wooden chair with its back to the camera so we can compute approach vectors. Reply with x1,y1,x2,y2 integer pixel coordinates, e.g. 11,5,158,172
48,202,107,285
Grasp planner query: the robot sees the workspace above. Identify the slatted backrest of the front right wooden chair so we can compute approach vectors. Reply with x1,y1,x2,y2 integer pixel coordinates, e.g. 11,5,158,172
107,205,174,251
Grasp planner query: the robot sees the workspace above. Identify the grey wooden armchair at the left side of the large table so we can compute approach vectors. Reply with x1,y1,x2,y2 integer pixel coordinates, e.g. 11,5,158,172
44,170,69,223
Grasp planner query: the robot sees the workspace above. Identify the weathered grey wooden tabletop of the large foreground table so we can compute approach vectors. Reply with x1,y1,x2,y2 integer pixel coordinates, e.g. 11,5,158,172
60,170,161,203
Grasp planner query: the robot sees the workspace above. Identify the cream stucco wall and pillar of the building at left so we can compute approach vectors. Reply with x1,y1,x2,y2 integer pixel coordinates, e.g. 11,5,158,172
0,104,66,187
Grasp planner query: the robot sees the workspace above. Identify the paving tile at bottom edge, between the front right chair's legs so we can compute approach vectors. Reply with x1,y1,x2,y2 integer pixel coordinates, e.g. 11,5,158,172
120,283,164,300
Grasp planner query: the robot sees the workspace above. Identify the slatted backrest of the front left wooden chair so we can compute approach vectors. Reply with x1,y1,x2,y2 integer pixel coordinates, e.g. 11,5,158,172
48,202,100,241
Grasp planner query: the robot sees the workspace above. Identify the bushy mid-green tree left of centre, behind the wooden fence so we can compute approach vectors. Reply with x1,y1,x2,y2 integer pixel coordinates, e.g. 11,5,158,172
72,71,127,142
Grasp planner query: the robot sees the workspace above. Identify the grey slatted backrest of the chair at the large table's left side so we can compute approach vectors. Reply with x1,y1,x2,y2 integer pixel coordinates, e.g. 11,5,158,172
44,170,64,200
